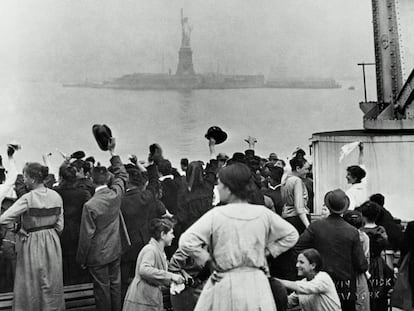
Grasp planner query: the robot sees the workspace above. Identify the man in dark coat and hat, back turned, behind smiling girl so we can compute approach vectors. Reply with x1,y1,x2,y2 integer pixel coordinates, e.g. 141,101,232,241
295,189,368,311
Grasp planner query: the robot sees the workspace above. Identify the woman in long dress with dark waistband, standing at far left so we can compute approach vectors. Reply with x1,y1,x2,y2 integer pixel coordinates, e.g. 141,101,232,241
0,163,65,311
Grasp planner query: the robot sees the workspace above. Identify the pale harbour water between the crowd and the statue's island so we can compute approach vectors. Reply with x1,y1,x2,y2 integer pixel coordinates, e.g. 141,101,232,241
0,82,363,171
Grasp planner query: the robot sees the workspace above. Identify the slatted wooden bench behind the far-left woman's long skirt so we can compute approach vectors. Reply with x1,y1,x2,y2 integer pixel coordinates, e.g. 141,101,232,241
0,283,96,311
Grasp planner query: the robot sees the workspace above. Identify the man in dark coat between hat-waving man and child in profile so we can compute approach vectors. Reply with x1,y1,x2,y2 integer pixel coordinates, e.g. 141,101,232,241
121,162,166,297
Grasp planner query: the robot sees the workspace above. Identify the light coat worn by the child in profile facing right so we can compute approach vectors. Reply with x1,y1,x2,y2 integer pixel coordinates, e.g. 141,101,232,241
122,238,172,311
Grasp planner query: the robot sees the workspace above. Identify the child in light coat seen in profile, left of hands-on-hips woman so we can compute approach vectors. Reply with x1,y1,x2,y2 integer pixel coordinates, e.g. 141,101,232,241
122,218,184,311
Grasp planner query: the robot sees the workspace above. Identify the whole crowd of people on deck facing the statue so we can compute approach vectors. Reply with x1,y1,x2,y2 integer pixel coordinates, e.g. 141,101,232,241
0,128,414,311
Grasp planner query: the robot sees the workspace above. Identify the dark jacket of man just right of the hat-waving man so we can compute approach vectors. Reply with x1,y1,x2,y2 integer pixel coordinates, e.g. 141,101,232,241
121,165,166,262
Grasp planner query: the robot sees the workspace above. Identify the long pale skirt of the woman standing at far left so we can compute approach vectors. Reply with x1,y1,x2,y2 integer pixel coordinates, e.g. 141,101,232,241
13,229,65,311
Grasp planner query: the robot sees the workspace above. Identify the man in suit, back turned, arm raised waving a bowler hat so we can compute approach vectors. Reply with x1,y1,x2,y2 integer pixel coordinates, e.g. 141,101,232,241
76,138,128,311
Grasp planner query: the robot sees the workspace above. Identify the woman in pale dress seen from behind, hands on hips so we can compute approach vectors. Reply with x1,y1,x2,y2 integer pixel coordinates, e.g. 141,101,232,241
179,163,298,311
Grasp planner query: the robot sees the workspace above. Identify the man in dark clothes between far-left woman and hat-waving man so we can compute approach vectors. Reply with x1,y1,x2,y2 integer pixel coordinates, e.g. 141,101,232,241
54,165,91,285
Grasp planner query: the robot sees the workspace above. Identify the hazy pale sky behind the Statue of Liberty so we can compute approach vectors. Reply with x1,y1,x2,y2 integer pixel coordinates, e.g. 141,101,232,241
0,0,414,81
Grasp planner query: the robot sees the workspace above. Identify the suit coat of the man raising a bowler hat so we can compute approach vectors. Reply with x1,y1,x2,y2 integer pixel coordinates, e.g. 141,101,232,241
76,156,128,266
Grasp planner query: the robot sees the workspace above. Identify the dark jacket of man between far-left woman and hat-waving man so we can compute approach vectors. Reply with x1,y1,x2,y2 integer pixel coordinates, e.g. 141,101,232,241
54,182,91,257
